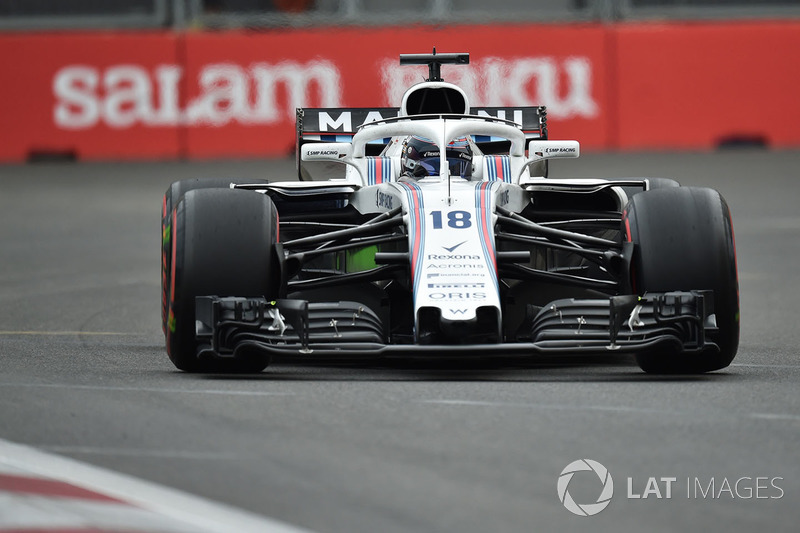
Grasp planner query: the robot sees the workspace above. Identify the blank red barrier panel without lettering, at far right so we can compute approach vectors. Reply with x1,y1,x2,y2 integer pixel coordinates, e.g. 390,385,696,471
609,21,800,149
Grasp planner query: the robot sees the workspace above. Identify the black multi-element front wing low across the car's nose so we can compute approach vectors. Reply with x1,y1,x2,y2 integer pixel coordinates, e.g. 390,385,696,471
196,291,719,359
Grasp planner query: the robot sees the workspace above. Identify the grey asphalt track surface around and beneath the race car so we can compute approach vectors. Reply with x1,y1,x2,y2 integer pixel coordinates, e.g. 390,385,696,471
0,150,800,533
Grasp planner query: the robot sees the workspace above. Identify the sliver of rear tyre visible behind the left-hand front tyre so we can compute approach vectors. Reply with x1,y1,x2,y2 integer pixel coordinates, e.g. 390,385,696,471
161,178,269,334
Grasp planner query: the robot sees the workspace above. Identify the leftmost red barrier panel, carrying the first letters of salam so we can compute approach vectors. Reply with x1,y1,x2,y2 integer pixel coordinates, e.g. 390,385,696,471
0,32,179,161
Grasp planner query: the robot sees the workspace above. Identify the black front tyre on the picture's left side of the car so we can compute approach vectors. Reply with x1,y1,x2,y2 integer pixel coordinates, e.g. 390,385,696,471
165,188,280,372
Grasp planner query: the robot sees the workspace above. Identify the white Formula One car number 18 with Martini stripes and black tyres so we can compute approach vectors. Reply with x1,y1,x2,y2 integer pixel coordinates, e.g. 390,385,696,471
162,51,739,373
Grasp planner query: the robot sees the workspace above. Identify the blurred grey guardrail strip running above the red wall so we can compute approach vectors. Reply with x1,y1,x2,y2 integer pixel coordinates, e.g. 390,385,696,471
0,0,800,31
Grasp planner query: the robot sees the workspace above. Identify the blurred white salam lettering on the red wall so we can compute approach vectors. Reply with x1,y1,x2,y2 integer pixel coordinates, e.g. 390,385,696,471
53,61,341,130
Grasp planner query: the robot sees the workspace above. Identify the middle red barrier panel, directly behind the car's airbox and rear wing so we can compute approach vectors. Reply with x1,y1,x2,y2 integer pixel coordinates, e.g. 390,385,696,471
181,26,609,157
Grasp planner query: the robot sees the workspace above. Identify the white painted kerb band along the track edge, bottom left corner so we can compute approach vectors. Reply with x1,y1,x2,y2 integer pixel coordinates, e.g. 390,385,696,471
0,439,318,533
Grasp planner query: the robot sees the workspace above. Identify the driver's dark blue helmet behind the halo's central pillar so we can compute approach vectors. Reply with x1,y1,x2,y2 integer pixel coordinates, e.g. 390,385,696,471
400,135,472,179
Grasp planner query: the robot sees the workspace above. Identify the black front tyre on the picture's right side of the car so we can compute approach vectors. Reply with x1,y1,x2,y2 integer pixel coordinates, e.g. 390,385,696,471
623,187,739,374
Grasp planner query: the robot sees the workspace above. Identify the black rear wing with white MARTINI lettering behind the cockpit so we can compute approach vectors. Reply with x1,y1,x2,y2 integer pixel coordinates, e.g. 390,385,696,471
296,106,547,180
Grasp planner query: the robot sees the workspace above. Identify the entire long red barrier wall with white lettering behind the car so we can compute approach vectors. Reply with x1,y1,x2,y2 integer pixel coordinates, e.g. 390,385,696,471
0,21,800,161
